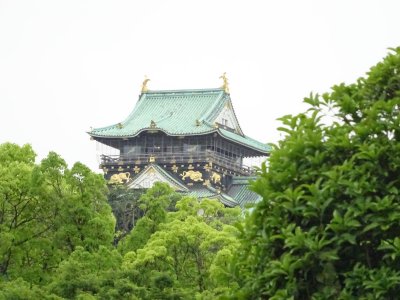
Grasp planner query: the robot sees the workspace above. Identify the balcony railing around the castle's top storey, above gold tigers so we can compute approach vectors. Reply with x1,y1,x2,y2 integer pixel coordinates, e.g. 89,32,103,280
100,150,255,175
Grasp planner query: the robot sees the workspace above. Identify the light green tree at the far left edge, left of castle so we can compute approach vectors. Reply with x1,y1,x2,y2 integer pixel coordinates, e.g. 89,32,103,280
0,143,115,284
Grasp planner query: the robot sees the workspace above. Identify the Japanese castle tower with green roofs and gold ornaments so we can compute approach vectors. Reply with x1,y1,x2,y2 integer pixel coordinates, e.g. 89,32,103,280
88,74,271,207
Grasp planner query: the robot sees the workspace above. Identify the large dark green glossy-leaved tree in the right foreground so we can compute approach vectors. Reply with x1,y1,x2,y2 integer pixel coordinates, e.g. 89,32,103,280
234,48,400,299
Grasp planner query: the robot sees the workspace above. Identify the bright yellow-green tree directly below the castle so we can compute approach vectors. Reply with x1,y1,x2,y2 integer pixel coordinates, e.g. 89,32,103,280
118,184,240,299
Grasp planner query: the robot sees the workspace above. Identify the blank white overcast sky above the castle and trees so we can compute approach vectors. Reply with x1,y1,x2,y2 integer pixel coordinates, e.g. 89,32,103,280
0,0,400,171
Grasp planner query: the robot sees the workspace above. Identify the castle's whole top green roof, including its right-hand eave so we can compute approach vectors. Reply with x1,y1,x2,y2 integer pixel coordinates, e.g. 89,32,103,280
89,88,271,154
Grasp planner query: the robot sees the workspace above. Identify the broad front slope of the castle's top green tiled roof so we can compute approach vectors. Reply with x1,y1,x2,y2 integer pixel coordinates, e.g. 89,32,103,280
90,89,225,137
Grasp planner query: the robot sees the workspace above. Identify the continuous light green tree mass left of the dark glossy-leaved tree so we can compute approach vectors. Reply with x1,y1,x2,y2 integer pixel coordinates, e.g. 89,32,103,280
0,143,240,299
